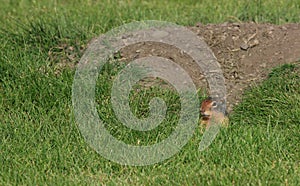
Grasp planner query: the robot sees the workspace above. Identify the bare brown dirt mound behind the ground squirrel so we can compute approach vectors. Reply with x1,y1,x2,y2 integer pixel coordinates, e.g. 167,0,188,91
121,23,300,111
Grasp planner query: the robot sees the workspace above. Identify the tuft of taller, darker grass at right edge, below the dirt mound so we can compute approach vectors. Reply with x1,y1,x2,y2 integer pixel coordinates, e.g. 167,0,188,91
235,62,300,126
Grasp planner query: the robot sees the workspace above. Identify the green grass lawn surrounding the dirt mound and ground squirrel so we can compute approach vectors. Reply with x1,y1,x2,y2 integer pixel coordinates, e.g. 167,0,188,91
0,0,300,185
